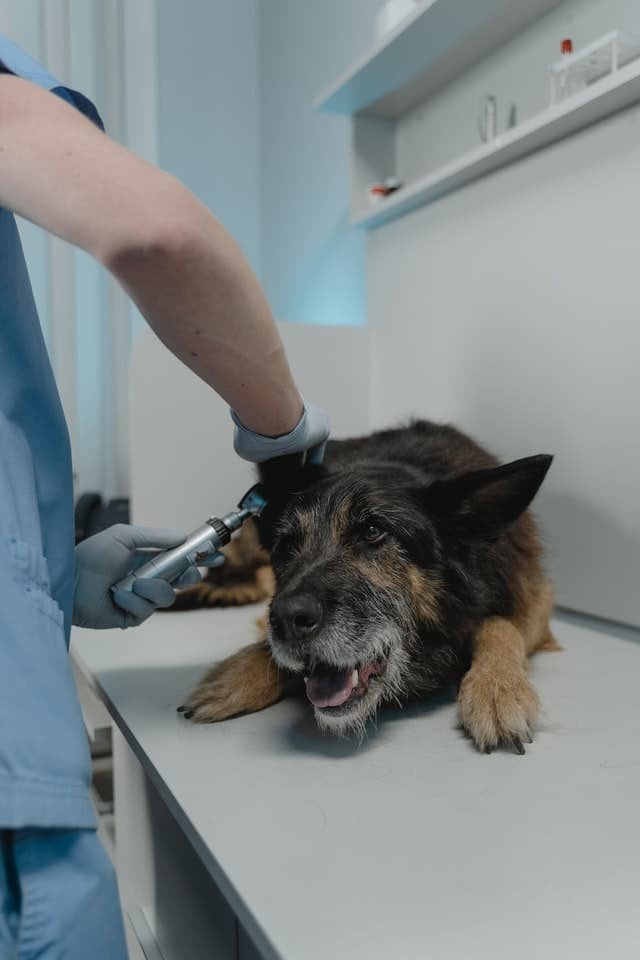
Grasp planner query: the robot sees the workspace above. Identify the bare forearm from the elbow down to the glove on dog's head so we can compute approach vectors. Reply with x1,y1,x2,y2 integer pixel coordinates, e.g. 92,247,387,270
111,208,303,436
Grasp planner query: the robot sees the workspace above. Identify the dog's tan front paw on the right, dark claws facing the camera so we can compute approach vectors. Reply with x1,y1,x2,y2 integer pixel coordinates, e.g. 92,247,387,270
458,666,539,753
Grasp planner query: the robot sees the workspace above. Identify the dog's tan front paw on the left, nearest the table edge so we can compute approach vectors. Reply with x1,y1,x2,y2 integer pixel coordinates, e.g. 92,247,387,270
178,643,284,723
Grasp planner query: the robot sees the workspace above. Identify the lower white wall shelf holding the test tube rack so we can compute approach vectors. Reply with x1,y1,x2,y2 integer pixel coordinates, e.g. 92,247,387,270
352,60,640,229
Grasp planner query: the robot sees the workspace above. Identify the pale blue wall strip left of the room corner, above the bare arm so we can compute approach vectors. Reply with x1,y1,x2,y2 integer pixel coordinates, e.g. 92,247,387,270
156,0,261,273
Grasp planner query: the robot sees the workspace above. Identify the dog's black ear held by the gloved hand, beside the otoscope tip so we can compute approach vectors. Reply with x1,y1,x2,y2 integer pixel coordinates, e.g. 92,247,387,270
255,453,327,550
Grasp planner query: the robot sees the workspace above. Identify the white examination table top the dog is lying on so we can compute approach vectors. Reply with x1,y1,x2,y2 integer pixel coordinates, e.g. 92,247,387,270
73,607,640,960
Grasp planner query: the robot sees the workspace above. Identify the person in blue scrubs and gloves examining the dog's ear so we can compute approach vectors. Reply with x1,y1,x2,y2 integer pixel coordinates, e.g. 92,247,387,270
0,37,329,960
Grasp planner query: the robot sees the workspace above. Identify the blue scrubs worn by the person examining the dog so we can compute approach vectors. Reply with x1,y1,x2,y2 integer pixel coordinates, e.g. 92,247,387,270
0,36,126,960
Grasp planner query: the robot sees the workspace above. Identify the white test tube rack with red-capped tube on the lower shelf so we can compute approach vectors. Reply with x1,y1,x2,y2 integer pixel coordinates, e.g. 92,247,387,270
550,30,640,105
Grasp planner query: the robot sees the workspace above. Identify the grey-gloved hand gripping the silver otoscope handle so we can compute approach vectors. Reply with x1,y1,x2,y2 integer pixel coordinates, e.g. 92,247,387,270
73,523,224,630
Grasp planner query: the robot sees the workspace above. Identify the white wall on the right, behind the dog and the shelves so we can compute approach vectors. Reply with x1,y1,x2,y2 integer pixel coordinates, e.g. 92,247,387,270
367,0,640,624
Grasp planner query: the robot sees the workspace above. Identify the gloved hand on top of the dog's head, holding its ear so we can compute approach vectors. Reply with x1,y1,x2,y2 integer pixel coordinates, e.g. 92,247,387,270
231,403,331,463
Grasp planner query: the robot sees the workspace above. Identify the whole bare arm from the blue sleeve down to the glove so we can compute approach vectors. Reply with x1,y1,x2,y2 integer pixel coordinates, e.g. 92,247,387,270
0,76,302,435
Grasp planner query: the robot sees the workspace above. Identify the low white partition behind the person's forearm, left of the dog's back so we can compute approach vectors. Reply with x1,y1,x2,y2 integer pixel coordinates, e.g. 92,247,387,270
130,323,369,530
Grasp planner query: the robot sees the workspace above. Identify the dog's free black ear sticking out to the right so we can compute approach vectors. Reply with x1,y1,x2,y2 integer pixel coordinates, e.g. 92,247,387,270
426,454,553,540
